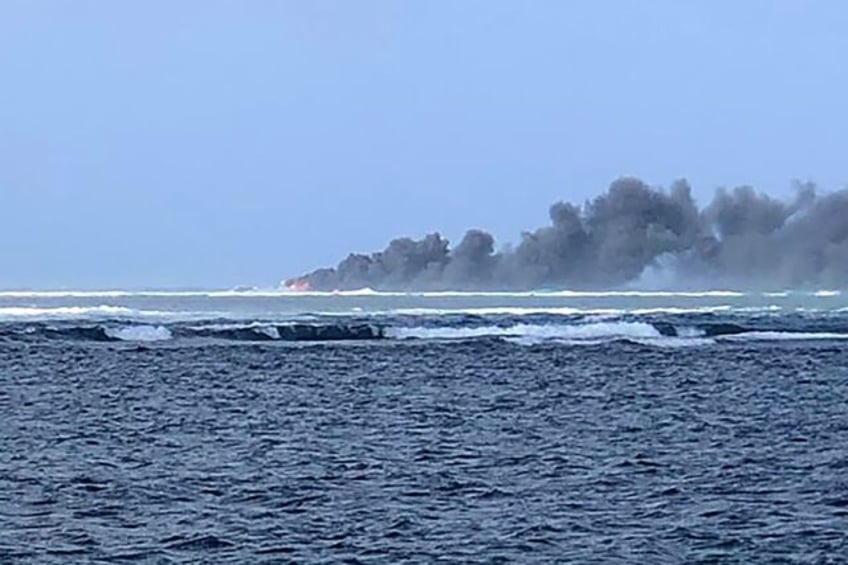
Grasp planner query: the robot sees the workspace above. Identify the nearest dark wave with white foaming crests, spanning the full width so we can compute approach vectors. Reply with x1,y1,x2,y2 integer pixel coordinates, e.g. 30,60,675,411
6,316,848,347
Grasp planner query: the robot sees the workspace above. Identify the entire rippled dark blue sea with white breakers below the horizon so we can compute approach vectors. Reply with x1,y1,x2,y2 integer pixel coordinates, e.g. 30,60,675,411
0,291,848,564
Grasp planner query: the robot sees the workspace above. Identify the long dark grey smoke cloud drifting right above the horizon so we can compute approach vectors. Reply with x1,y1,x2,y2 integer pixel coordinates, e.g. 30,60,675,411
286,178,848,290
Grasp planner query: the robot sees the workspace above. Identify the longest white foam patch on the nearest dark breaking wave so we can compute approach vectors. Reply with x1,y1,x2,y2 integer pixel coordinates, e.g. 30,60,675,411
386,322,661,339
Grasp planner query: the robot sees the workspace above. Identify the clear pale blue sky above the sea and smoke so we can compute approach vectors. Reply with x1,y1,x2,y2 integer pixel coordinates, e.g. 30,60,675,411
0,0,848,289
